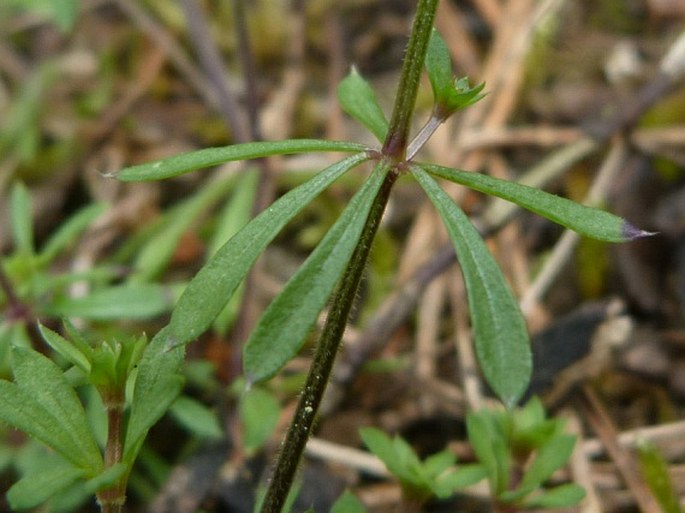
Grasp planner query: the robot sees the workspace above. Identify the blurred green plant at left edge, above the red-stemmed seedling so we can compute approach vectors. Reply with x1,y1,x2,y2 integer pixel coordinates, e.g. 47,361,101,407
0,182,176,356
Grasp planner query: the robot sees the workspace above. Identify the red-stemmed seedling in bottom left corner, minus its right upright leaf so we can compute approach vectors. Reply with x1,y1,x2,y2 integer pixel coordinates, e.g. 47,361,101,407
0,326,158,512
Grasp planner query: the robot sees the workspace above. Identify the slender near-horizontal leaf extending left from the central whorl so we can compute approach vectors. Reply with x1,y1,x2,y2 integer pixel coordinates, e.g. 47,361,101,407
110,139,367,182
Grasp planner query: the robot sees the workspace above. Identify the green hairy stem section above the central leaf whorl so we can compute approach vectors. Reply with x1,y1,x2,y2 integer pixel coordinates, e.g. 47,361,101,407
382,0,438,162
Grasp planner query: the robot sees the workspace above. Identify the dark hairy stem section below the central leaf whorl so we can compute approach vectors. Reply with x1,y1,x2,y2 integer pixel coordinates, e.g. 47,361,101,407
261,168,399,513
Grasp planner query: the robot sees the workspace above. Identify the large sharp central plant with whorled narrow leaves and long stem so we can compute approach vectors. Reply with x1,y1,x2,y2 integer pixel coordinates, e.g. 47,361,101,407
111,0,645,512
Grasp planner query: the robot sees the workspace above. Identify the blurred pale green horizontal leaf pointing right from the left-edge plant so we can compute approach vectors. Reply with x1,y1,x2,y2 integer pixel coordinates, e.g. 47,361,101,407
45,283,173,320
